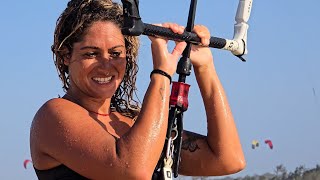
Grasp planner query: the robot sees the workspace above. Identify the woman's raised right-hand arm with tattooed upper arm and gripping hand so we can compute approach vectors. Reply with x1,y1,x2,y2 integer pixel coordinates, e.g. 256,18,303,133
180,25,245,176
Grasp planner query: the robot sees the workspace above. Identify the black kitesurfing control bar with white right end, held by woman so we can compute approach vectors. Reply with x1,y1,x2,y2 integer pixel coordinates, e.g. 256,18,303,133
122,0,252,61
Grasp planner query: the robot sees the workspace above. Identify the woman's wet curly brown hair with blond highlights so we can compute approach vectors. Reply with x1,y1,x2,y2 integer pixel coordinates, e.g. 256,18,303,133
51,0,140,118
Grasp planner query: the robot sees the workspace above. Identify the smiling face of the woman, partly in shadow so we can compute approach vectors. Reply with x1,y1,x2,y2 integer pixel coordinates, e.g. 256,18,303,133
64,21,126,99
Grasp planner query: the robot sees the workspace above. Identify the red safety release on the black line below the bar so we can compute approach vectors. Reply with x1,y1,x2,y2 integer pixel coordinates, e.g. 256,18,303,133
170,82,190,111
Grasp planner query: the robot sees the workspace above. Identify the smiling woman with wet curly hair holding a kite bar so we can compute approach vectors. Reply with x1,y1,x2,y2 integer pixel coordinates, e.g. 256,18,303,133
30,0,245,180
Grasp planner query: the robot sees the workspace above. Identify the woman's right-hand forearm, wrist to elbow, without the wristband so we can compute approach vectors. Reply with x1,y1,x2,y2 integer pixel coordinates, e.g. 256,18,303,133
195,62,244,163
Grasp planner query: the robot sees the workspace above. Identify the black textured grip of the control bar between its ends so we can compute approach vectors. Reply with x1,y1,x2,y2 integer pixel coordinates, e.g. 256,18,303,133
142,23,226,49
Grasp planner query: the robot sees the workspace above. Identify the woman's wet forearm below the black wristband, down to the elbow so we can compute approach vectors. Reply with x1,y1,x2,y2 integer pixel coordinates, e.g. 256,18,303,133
119,74,170,171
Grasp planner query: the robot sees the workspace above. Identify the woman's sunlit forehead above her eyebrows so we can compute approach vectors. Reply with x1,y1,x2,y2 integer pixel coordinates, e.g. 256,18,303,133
81,21,125,45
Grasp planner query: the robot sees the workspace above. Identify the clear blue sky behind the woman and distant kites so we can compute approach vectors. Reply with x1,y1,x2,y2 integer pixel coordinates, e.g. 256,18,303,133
0,0,320,180
